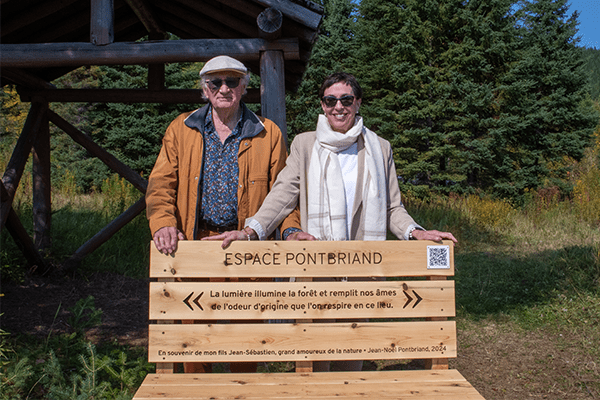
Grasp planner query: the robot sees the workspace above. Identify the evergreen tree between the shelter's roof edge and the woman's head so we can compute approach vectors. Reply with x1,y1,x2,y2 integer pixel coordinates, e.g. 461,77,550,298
286,0,356,138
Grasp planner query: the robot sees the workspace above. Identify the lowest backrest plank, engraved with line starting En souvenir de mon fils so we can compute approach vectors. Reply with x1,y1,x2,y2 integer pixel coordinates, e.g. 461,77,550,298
148,321,456,362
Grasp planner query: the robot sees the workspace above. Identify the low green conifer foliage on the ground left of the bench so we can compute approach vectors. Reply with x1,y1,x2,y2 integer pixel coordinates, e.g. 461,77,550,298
0,297,152,400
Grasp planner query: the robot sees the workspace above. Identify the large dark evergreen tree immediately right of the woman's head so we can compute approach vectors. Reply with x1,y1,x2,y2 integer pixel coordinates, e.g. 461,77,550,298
355,0,514,192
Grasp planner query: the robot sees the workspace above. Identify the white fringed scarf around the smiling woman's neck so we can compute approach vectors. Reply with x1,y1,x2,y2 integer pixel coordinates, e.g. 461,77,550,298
308,114,387,240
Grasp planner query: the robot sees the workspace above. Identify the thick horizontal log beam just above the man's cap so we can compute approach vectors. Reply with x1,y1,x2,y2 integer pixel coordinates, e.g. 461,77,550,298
0,38,300,68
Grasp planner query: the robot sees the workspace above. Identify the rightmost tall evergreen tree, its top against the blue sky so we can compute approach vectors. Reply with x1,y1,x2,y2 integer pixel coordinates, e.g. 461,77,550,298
490,0,597,197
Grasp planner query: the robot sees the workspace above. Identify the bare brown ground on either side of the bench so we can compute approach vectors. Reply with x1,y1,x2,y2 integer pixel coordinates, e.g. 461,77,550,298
0,273,600,400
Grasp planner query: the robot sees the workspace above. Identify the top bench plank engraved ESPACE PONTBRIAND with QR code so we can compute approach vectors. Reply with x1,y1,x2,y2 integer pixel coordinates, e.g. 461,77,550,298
150,240,454,278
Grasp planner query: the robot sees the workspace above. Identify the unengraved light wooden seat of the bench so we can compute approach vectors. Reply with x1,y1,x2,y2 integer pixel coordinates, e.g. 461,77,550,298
134,370,483,400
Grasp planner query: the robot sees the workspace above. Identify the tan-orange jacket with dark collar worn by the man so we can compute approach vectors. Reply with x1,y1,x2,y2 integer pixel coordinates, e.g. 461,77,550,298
146,103,300,240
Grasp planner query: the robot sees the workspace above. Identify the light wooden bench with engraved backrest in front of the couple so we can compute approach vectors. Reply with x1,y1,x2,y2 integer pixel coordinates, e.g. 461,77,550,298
134,241,483,400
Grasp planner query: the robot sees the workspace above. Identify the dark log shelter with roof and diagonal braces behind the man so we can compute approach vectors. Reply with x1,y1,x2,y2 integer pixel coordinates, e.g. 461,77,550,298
0,0,323,266
